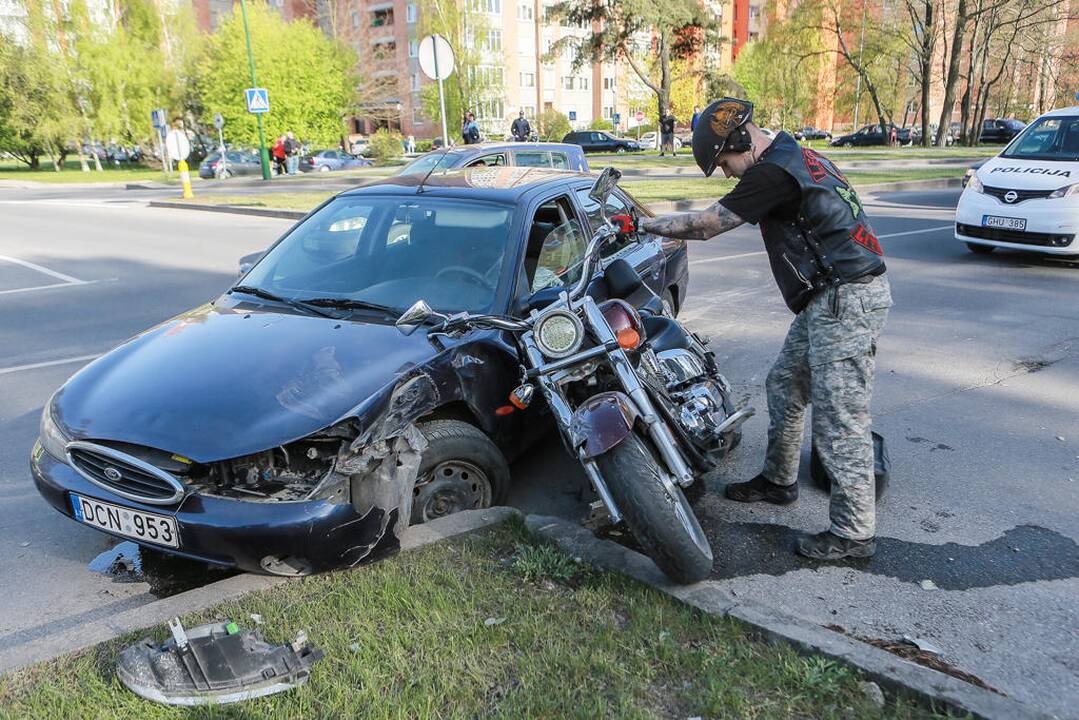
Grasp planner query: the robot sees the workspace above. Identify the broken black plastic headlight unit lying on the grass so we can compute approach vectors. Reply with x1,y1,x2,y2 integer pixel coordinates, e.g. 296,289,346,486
117,617,323,705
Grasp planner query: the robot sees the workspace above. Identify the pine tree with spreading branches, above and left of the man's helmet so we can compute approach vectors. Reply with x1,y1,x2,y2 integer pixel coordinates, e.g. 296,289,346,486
548,0,716,122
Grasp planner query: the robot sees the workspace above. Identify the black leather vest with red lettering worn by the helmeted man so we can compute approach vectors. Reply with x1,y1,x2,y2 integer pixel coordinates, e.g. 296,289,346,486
757,133,885,313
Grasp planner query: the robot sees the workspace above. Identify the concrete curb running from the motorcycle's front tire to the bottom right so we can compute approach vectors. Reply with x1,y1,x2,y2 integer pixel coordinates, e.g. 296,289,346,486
524,515,1054,720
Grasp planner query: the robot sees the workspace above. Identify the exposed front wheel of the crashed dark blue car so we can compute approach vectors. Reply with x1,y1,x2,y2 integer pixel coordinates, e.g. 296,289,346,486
410,420,509,525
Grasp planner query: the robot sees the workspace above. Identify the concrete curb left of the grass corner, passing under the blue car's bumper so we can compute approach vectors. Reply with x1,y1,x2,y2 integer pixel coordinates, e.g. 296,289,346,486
0,507,520,675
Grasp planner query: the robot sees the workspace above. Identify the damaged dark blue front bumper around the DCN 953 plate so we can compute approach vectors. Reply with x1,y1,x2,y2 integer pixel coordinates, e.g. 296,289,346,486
30,444,398,574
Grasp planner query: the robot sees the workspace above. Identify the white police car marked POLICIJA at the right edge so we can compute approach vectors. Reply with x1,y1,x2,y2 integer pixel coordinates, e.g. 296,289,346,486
955,107,1079,256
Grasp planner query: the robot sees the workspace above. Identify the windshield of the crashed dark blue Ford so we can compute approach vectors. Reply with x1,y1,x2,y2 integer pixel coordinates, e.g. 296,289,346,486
243,195,514,313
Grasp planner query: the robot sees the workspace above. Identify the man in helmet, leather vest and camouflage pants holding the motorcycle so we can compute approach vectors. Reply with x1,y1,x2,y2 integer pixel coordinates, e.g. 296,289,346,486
641,97,892,560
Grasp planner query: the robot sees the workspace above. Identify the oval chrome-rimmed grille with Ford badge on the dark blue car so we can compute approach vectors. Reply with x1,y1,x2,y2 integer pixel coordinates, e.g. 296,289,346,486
67,440,185,505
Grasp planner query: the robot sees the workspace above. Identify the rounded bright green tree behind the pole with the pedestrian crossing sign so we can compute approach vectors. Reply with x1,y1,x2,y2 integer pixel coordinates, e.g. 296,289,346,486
196,2,356,145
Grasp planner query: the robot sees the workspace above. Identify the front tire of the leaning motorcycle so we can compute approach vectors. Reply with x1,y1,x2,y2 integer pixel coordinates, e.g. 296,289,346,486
596,433,714,585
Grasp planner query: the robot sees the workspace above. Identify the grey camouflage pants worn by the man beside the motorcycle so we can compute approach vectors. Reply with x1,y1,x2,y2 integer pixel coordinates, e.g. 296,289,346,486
762,275,891,540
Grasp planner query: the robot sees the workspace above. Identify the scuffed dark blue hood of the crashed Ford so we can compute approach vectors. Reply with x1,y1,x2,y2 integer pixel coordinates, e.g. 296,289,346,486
53,304,436,462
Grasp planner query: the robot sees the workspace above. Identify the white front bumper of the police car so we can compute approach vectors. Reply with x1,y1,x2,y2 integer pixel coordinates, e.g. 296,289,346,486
955,188,1079,255
